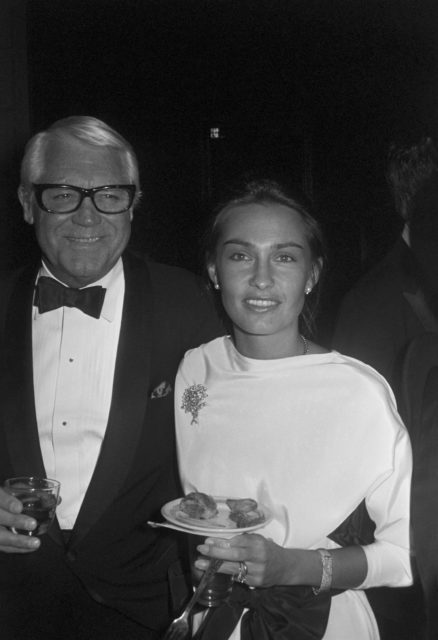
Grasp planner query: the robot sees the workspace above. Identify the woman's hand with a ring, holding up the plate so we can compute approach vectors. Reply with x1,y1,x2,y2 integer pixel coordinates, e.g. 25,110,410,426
195,533,293,587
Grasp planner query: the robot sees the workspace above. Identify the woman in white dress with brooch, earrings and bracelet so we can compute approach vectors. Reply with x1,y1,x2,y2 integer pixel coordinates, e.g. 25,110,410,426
175,181,412,640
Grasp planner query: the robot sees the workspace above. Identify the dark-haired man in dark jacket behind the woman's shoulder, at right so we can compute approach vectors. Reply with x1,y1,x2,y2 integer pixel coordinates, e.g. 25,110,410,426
332,138,438,640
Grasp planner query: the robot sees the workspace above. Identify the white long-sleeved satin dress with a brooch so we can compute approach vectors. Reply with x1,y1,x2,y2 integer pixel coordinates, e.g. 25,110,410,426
175,337,412,640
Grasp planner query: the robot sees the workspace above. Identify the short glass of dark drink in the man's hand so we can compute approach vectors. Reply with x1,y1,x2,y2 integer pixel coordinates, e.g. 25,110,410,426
4,476,61,536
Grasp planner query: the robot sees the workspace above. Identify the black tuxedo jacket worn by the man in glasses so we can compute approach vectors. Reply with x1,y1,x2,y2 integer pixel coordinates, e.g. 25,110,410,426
0,255,222,630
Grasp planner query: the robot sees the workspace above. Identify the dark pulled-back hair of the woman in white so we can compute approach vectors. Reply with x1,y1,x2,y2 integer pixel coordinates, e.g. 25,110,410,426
204,177,326,336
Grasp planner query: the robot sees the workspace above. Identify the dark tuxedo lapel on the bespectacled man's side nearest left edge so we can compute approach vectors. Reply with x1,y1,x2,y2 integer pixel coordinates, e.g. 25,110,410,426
2,268,45,476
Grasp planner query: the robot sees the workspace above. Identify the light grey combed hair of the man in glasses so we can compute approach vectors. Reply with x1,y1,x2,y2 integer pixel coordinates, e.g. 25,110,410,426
21,116,140,200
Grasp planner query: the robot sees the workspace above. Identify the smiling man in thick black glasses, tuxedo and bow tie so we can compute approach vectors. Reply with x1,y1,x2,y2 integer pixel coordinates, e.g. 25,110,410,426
0,116,221,640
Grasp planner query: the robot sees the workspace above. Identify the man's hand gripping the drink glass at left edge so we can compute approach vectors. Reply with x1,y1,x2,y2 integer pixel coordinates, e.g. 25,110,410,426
0,489,41,553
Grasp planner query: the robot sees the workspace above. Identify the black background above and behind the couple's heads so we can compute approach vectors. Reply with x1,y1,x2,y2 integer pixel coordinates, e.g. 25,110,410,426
14,0,438,338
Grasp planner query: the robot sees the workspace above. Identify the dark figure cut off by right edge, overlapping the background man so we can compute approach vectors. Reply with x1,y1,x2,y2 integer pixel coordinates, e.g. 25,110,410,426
397,179,438,640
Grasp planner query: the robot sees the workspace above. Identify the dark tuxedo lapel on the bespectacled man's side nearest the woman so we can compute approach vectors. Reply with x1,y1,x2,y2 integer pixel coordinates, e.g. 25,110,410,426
70,257,152,545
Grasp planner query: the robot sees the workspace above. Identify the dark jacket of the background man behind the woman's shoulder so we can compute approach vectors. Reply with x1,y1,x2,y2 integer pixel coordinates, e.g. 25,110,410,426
332,238,428,640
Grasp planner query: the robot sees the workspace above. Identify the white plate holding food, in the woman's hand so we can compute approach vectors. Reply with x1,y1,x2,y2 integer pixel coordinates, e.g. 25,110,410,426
161,496,272,536
